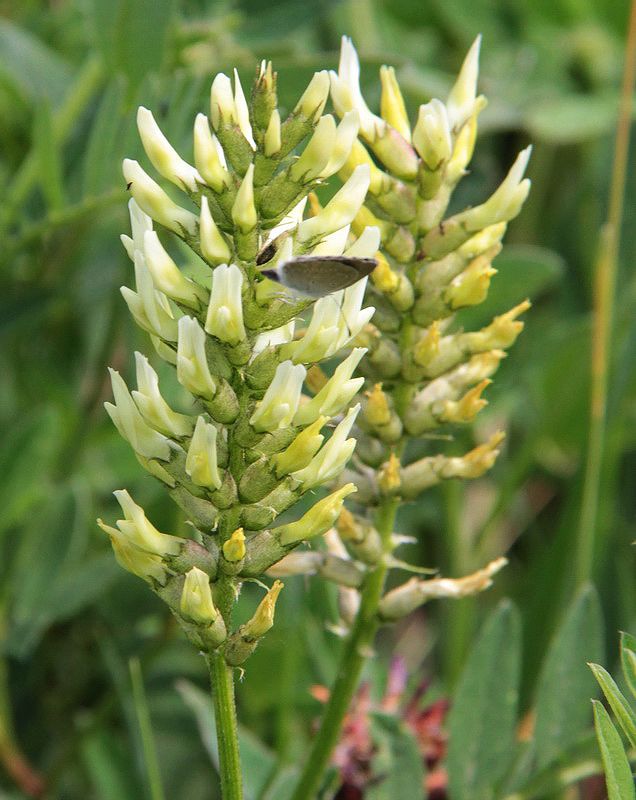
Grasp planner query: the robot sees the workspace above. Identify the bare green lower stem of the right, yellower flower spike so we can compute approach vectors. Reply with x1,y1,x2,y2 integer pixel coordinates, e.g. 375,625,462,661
291,499,398,800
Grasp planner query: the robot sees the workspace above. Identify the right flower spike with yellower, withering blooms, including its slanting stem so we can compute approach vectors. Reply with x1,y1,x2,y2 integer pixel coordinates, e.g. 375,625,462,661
286,38,530,800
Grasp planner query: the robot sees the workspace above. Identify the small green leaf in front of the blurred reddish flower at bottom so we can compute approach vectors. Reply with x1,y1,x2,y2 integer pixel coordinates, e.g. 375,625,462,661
365,713,424,800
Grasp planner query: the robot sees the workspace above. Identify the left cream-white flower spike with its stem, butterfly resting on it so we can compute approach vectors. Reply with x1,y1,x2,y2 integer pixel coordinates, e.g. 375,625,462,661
99,63,379,800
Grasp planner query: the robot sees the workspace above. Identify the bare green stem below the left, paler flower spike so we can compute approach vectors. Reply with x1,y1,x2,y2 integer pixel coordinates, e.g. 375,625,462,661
208,652,243,800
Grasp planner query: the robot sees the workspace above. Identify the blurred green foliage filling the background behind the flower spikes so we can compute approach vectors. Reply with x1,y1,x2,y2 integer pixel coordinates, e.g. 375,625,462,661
0,0,636,800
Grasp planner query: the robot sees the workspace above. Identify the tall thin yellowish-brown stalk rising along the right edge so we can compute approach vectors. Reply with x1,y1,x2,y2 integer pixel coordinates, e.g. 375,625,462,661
576,0,636,584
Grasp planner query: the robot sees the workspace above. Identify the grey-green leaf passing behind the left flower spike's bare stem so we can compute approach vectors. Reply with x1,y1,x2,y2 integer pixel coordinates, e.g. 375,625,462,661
177,681,284,800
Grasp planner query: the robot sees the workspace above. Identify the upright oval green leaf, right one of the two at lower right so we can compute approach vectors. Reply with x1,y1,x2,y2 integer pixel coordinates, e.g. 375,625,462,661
534,586,603,769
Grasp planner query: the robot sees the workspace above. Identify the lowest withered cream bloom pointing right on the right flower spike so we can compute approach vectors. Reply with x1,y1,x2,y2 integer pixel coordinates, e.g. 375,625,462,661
379,558,508,620
